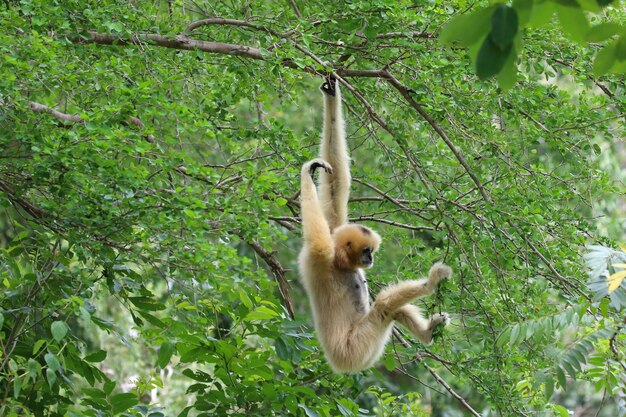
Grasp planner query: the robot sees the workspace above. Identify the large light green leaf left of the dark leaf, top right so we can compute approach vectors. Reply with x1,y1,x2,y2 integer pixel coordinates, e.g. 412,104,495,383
439,7,494,47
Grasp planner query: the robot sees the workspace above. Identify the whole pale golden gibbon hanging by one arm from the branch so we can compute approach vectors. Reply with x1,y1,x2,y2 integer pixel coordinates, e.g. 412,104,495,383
298,78,452,373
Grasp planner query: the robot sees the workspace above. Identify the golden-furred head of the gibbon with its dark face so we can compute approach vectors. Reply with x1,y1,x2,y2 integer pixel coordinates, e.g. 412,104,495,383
333,224,381,269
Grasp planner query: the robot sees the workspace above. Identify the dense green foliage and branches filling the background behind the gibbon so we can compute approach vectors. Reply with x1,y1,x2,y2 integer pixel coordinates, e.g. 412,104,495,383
0,0,626,417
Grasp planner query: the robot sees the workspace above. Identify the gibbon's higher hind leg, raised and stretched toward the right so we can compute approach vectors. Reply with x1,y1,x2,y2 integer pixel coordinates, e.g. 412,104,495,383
373,263,452,317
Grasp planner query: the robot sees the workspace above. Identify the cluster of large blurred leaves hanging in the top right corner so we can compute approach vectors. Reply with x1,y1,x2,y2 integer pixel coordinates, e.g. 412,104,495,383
439,0,626,90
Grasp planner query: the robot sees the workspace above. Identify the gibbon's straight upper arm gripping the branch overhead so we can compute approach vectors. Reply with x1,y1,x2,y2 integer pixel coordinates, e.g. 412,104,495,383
319,76,351,231
